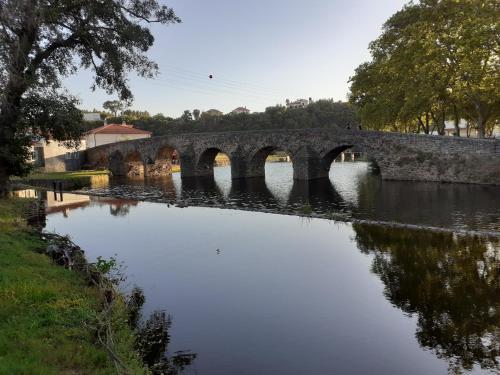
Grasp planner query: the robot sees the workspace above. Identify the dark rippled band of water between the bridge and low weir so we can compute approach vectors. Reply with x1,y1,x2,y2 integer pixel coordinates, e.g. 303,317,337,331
81,164,500,235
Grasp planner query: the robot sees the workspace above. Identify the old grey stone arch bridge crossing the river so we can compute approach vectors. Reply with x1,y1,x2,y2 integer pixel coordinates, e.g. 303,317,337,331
84,128,500,186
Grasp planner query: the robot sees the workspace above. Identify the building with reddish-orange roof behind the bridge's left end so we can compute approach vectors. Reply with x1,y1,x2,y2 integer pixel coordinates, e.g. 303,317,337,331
85,123,151,148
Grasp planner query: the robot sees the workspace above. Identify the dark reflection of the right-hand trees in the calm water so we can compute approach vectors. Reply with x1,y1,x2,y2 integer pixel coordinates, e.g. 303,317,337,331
354,224,500,373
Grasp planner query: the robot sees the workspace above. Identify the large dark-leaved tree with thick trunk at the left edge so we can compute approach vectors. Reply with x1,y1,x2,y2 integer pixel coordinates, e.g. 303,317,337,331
0,0,180,190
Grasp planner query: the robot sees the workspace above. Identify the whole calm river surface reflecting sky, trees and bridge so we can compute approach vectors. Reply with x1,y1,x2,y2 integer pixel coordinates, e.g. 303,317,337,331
38,163,500,375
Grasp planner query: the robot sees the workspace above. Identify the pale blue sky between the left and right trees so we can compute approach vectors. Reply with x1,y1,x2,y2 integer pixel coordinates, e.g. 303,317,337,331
65,0,408,117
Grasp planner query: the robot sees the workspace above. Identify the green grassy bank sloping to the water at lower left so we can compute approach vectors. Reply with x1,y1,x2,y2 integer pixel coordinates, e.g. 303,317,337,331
0,199,145,375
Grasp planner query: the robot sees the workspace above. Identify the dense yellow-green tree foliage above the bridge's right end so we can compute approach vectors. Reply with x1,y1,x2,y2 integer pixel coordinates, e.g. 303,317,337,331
350,0,500,137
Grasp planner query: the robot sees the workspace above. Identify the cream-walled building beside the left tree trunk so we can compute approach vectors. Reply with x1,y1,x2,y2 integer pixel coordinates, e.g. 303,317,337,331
29,138,86,172
